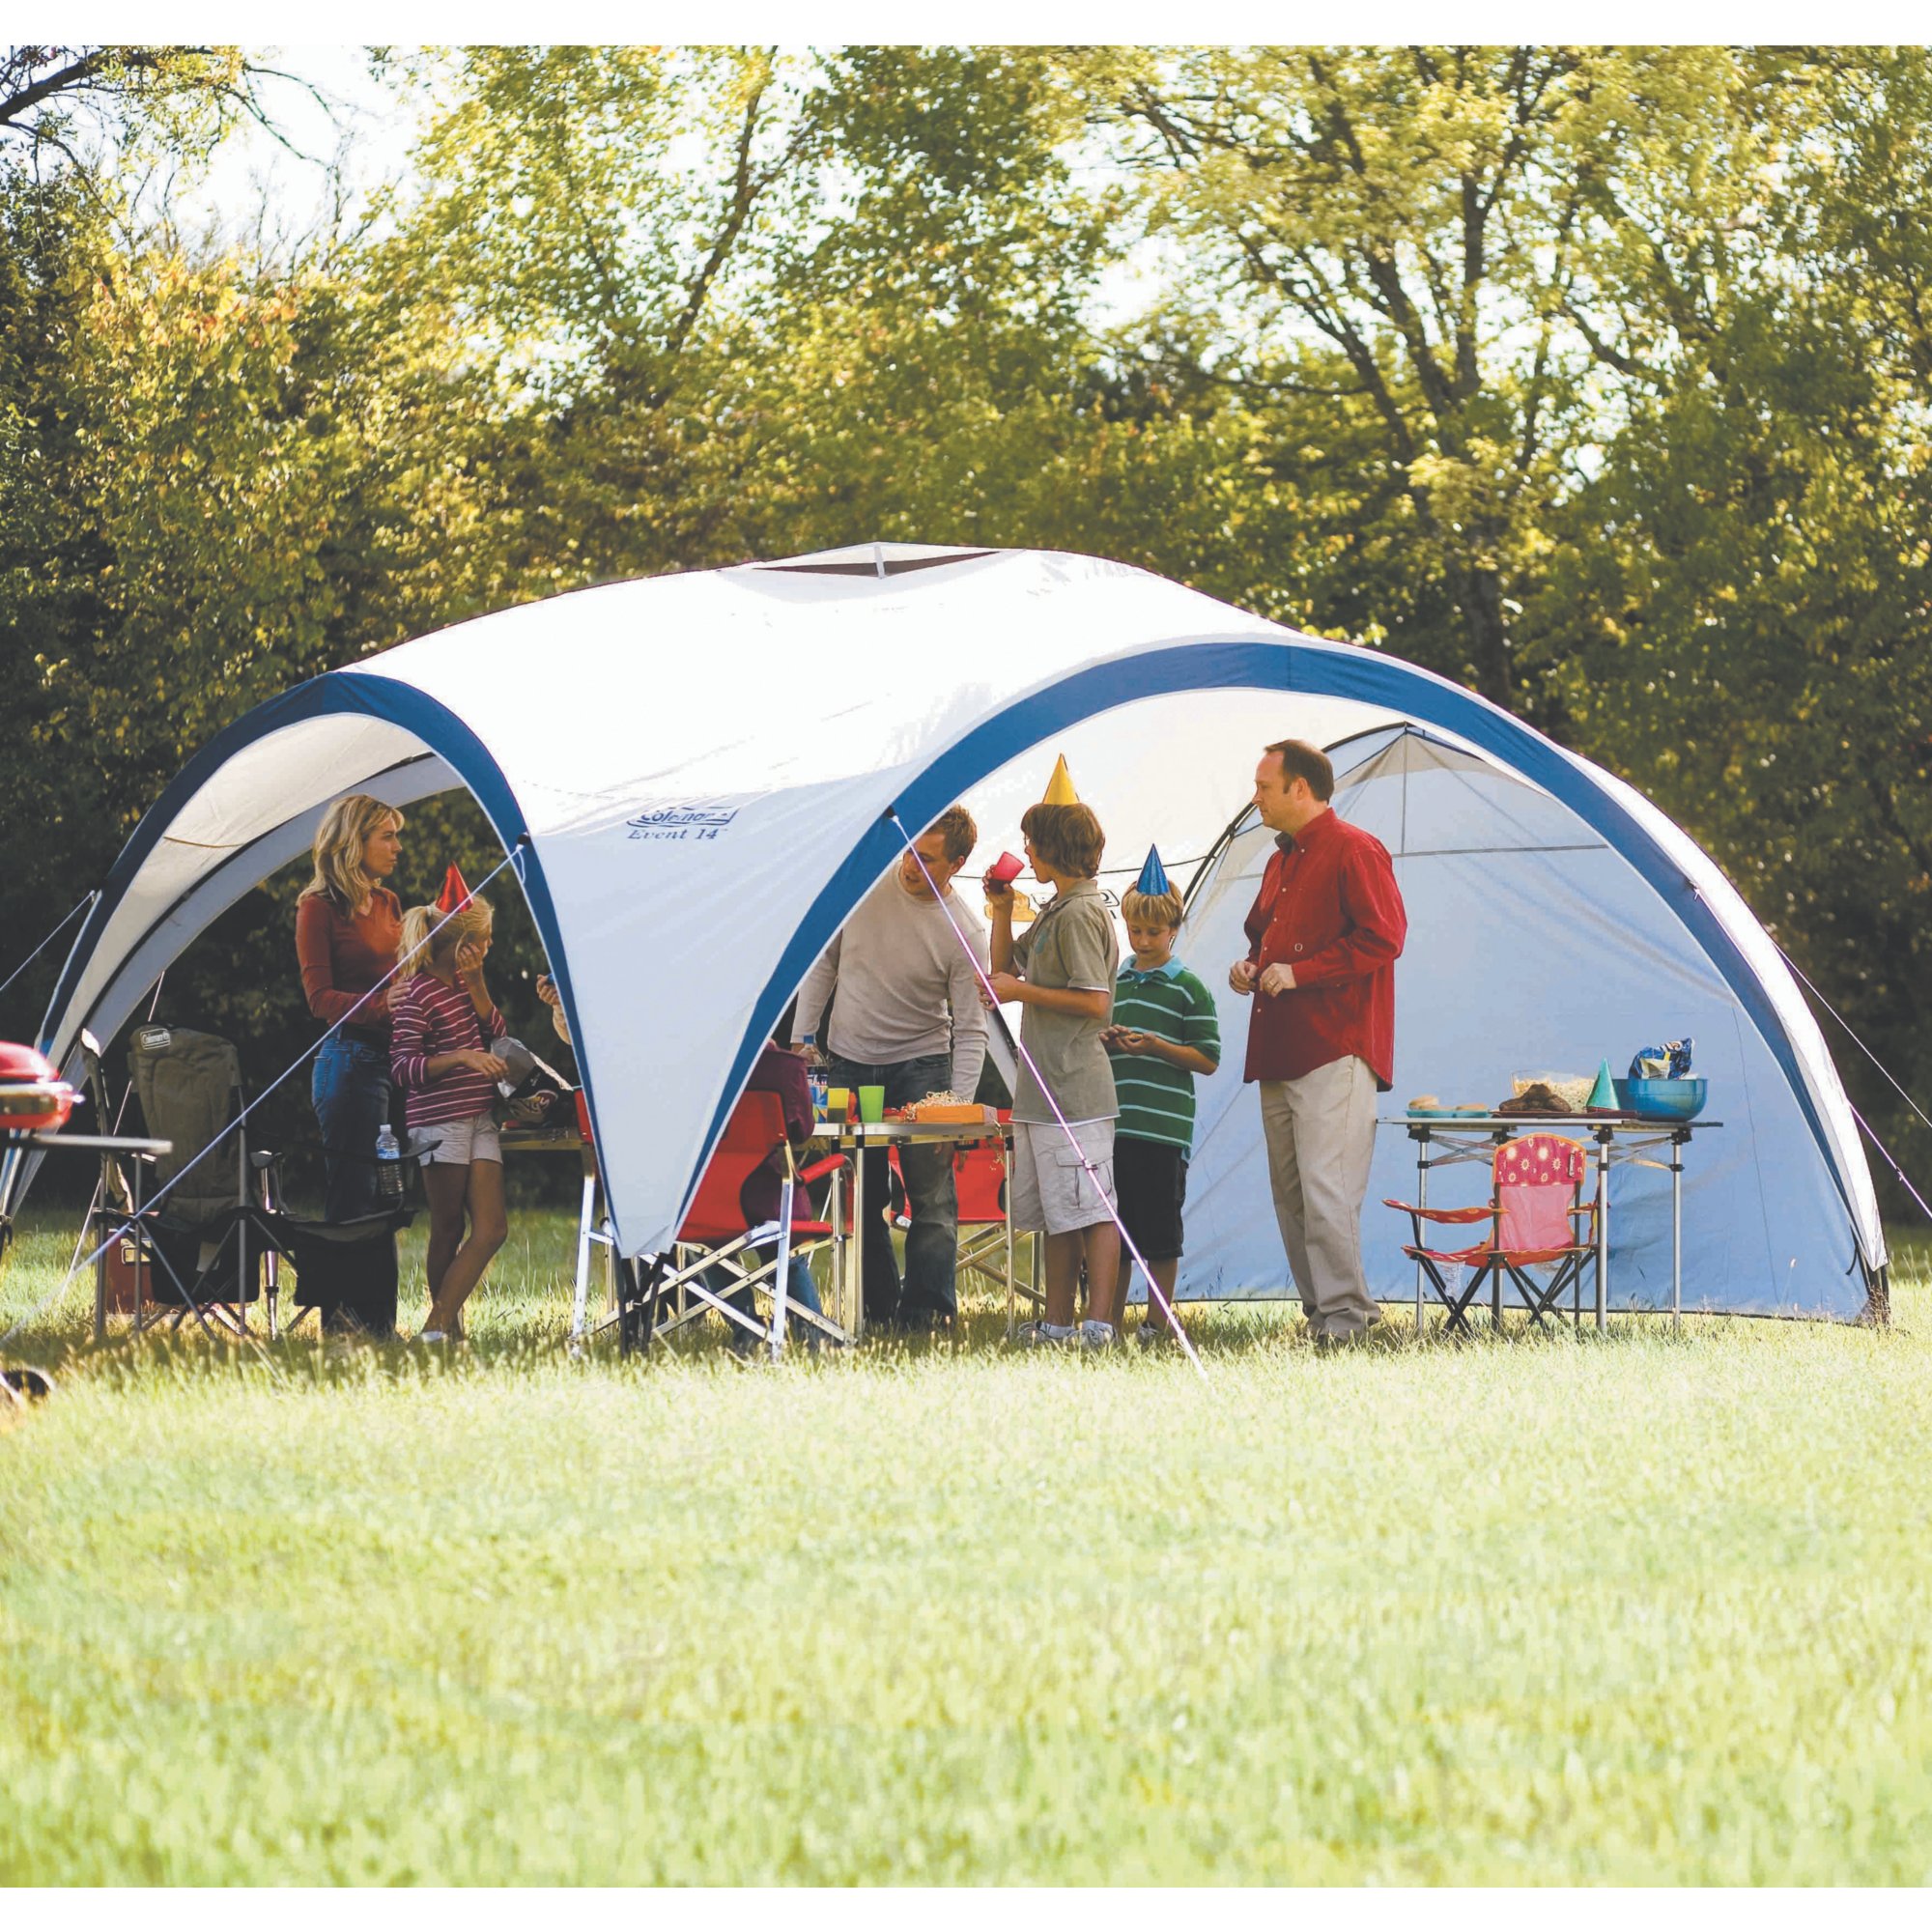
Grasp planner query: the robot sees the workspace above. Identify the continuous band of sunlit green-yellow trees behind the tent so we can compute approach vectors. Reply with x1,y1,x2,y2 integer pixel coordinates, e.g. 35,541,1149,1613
0,46,1932,1206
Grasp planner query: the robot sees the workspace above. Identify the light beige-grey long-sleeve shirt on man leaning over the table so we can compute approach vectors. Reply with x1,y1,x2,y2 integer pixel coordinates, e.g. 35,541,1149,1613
792,867,989,1099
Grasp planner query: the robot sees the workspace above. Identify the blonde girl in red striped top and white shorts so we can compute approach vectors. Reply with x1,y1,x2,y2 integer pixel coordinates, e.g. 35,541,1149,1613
388,898,510,1341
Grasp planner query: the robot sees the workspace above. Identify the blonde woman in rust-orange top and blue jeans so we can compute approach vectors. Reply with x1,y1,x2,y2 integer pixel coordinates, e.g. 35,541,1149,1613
296,792,402,1221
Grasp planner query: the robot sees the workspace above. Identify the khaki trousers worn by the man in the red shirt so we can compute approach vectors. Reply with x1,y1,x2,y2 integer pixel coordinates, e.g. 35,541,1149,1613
1258,1057,1379,1337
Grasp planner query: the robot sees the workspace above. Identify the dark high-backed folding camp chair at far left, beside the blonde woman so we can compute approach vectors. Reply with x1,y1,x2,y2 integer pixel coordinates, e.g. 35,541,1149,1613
114,1026,413,1337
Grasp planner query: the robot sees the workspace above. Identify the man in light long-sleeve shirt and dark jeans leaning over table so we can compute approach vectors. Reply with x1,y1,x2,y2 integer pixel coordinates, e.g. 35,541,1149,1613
792,806,987,1331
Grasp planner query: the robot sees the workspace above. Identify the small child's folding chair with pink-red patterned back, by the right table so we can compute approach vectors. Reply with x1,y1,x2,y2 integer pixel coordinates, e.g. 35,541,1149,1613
1381,1134,1596,1335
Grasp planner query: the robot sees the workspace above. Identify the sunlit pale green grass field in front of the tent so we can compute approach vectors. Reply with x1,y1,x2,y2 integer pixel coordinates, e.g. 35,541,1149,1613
0,1217,1932,1884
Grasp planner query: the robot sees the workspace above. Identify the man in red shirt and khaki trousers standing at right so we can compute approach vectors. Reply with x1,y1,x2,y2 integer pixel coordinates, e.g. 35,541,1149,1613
1227,738,1408,1341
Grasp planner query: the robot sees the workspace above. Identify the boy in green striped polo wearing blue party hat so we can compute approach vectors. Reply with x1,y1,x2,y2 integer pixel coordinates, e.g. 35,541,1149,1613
1101,850,1221,1343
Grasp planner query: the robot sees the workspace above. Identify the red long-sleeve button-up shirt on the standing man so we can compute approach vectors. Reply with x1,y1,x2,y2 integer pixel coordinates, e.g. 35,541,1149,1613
1244,811,1408,1092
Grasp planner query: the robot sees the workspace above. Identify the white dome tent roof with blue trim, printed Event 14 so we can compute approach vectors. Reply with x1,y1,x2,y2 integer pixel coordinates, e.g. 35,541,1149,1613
14,545,1884,1306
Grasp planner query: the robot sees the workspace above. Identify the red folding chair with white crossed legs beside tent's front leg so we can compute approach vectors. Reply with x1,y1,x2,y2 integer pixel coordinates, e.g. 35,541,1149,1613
618,1094,850,1356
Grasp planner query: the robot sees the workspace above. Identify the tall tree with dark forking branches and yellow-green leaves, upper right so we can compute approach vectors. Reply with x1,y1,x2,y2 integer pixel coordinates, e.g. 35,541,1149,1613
1068,46,1762,707
